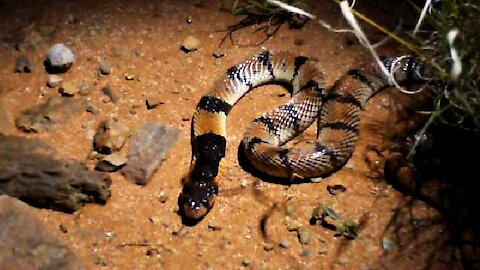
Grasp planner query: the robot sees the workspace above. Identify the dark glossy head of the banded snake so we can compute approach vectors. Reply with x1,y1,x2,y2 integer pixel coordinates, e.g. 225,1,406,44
180,180,218,220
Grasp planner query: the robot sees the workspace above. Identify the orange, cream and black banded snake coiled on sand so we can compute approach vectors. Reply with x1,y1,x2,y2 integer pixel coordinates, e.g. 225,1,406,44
179,51,429,220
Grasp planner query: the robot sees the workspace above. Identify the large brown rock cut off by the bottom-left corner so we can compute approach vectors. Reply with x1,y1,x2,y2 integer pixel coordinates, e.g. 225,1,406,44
0,196,87,270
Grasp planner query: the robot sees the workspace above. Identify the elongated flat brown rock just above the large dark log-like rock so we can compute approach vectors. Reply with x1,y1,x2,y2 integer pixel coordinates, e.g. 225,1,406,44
15,97,88,132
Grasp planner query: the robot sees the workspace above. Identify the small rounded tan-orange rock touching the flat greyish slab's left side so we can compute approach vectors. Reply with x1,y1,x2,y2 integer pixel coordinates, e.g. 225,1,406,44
93,119,129,154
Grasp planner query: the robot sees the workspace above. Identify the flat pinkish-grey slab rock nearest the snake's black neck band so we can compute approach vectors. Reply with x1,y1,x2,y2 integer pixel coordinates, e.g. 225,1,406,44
121,123,180,185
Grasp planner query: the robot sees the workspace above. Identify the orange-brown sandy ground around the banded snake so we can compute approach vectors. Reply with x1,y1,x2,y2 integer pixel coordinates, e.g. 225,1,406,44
0,1,464,269
